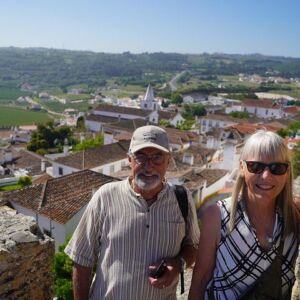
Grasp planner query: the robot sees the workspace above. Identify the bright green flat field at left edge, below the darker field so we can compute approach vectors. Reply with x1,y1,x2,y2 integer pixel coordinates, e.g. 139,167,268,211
0,105,51,127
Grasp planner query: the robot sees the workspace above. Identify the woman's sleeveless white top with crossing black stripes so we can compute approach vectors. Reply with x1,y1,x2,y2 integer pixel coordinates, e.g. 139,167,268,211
205,199,297,300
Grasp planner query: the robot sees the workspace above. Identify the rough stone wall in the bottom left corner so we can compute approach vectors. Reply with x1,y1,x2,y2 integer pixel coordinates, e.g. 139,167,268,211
0,206,54,300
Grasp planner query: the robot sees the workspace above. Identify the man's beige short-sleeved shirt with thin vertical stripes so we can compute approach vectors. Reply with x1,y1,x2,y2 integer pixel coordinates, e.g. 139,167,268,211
65,179,199,300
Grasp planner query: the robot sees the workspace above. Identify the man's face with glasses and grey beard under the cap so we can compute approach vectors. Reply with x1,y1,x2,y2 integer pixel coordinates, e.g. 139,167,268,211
128,148,169,191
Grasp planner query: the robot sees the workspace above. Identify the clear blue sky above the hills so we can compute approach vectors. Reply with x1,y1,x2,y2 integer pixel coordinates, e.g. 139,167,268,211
0,0,300,57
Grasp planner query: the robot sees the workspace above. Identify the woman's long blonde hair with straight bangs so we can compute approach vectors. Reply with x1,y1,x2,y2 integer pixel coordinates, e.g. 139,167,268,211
229,130,298,236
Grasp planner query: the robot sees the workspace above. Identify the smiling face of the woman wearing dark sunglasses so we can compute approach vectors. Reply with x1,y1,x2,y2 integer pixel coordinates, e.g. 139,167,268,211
240,157,289,201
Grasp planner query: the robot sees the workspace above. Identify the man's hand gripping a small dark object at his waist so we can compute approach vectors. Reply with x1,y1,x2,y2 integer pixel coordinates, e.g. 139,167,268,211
148,258,181,289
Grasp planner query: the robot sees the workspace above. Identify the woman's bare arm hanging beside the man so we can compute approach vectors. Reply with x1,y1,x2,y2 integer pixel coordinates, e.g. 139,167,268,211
188,204,221,300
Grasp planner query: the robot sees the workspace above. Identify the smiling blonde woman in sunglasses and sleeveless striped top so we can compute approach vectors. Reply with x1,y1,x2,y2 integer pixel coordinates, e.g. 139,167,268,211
189,131,299,300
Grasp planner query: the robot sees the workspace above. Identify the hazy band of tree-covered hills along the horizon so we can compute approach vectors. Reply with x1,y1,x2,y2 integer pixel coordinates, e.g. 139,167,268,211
0,47,300,90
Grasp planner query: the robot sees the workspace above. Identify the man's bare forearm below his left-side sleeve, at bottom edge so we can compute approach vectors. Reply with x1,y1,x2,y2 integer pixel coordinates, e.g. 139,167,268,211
72,263,92,300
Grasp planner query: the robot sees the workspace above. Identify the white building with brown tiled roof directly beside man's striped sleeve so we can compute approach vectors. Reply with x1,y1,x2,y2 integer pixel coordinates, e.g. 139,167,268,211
4,170,117,251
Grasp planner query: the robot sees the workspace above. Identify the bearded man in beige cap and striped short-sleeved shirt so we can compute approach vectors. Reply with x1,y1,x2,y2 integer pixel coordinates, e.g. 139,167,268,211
65,126,199,300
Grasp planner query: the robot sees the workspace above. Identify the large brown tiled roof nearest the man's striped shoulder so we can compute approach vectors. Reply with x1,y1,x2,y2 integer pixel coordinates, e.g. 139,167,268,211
3,170,118,224
